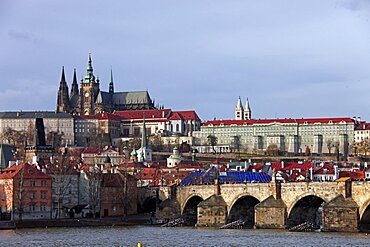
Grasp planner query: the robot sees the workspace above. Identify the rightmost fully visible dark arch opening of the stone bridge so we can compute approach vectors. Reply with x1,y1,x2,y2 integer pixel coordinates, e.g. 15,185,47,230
287,193,326,228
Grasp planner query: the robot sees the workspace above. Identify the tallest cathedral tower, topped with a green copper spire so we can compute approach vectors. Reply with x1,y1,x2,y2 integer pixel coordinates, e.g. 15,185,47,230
80,53,100,115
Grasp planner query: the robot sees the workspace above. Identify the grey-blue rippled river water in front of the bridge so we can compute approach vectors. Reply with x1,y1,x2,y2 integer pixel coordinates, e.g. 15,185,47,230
0,226,370,247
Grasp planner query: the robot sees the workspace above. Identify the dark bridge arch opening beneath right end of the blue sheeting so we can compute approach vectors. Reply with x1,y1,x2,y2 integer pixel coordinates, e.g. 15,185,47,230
227,194,260,227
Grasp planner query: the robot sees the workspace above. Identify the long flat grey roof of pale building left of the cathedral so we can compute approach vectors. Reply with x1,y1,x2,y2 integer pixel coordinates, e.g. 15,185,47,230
0,111,72,119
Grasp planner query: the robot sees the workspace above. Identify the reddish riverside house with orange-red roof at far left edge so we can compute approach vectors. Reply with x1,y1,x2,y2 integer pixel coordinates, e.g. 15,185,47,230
0,163,52,220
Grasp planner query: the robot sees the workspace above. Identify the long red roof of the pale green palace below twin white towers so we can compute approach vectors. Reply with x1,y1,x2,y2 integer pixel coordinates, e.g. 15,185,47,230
203,118,354,126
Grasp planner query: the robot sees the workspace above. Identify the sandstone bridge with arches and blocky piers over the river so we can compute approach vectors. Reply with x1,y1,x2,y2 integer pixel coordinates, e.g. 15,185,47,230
147,180,370,231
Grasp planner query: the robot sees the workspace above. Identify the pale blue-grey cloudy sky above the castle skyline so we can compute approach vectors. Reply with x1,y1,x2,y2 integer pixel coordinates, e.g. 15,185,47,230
0,0,370,121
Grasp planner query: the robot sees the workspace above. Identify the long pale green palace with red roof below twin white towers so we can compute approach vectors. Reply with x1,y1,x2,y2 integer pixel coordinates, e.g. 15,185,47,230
193,118,355,155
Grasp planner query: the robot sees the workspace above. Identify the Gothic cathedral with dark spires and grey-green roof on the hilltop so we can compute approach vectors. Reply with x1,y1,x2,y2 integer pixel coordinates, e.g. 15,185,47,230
56,54,155,115
